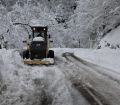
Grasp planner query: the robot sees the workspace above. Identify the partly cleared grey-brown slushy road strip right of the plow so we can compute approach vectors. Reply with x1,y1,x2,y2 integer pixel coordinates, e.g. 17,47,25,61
60,53,120,105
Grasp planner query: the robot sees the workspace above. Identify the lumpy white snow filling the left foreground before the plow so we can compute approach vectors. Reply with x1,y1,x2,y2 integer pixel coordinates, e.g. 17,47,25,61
0,49,88,105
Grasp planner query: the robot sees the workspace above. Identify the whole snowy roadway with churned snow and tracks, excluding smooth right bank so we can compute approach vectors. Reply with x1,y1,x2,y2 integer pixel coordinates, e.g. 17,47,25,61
0,49,120,105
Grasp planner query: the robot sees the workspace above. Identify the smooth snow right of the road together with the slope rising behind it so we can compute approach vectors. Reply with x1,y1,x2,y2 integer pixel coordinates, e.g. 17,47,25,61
74,27,120,72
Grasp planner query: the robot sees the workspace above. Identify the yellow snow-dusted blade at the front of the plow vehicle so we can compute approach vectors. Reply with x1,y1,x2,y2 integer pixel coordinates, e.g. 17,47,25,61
23,59,54,65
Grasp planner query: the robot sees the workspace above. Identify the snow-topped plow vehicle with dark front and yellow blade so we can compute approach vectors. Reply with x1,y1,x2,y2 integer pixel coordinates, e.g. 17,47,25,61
23,26,54,65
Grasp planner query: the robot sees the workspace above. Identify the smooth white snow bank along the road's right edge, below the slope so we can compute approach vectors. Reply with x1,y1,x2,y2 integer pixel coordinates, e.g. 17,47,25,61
74,48,120,72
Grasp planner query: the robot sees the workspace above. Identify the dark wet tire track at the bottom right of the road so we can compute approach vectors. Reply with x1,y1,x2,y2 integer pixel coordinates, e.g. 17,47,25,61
73,79,110,105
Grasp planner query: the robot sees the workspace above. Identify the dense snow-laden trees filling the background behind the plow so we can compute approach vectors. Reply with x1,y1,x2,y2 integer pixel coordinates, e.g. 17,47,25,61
0,0,120,48
